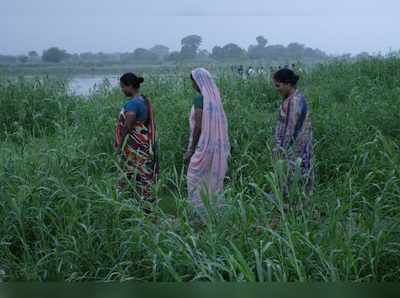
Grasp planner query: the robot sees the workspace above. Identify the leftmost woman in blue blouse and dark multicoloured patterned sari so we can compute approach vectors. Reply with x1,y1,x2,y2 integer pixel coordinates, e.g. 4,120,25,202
114,73,158,201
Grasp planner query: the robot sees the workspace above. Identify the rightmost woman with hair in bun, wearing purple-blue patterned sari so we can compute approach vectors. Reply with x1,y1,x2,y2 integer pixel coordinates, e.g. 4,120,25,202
274,69,314,195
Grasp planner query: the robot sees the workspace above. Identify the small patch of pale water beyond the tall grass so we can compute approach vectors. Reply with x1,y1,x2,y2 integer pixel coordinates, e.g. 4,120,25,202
69,75,119,96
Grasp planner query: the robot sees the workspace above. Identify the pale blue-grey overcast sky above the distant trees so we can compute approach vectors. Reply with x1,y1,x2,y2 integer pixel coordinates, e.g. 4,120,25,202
0,0,400,54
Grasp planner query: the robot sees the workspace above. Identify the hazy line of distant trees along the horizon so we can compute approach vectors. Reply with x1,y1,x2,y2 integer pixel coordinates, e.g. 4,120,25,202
0,35,369,64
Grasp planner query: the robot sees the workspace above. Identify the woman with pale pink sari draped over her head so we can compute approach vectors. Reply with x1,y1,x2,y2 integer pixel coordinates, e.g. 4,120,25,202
184,68,230,212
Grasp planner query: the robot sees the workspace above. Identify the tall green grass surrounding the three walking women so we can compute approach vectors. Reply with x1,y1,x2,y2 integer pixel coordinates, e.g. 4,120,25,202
0,59,400,281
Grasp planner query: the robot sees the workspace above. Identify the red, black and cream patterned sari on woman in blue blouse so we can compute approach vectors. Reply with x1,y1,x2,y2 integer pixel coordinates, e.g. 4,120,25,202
114,96,159,201
